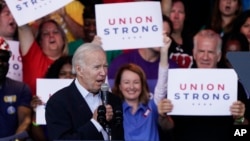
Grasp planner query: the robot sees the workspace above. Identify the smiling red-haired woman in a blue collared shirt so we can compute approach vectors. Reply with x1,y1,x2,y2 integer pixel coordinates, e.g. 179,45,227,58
112,32,173,141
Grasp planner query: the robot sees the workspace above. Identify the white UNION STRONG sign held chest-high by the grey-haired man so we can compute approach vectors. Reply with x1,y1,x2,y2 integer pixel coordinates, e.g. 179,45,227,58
167,69,238,116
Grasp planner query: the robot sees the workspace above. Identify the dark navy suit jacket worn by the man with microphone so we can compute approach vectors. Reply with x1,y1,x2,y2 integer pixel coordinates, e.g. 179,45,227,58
45,81,124,140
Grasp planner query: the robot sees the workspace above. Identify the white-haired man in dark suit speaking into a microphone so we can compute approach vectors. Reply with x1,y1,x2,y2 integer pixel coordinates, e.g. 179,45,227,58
46,43,124,140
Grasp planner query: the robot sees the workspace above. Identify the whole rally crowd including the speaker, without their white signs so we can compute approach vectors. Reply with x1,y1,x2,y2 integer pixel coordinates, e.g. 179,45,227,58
0,0,250,141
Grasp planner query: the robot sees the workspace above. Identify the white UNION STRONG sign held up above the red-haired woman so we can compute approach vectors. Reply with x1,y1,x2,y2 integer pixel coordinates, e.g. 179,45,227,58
95,1,163,50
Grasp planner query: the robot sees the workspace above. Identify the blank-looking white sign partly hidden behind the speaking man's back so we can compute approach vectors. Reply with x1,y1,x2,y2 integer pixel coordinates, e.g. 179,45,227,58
36,78,73,125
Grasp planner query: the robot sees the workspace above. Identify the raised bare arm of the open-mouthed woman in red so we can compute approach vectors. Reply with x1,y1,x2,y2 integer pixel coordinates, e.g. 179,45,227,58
18,25,35,56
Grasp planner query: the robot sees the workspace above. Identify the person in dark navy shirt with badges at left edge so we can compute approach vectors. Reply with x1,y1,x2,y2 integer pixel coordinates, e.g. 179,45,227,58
0,37,31,140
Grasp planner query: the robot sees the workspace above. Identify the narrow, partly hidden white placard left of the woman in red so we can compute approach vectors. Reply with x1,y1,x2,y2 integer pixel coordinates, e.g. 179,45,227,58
6,40,23,81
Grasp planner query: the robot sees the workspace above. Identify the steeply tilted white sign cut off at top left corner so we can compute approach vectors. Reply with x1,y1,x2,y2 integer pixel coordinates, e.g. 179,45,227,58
5,0,72,26
